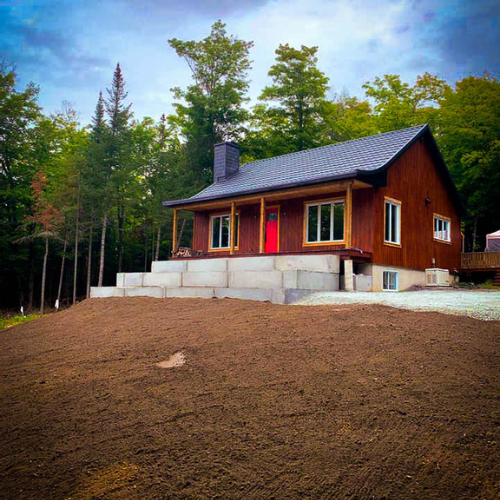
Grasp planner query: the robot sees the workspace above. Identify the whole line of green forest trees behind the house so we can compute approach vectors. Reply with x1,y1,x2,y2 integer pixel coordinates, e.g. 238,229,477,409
0,21,500,310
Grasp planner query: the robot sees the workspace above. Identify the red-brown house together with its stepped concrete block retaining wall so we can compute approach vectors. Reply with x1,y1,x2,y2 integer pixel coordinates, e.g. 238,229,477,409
90,125,464,303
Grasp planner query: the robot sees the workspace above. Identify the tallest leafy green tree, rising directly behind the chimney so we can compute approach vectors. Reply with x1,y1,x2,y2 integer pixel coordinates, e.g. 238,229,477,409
169,21,253,185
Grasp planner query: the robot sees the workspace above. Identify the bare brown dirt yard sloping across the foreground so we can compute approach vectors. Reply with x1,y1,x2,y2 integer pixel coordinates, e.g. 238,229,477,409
0,298,500,500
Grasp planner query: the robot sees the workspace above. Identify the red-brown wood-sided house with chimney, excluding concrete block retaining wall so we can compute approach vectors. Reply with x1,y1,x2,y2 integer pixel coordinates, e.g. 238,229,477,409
164,125,464,290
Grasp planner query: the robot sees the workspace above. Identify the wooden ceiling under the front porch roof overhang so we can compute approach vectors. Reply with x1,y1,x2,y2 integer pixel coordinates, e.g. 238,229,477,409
175,180,373,211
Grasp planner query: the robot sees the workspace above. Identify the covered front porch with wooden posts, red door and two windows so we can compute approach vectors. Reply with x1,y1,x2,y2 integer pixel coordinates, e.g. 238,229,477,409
172,180,373,263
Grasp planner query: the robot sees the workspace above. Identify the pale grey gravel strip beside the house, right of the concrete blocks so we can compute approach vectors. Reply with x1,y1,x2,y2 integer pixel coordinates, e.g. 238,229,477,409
297,290,500,320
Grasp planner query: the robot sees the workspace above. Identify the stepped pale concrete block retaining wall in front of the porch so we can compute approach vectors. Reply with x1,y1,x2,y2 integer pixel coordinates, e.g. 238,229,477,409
91,255,340,304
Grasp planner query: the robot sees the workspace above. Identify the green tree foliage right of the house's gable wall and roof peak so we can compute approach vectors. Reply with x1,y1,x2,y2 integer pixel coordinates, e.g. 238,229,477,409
438,75,500,249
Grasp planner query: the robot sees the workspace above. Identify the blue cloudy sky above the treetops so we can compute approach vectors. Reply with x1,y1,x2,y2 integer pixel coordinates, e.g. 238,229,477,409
0,0,500,125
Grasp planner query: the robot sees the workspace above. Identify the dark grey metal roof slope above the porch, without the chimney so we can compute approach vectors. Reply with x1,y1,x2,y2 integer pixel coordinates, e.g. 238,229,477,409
164,125,428,206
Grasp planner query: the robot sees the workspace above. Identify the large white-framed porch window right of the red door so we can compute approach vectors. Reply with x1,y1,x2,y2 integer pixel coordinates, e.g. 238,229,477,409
306,200,345,244
